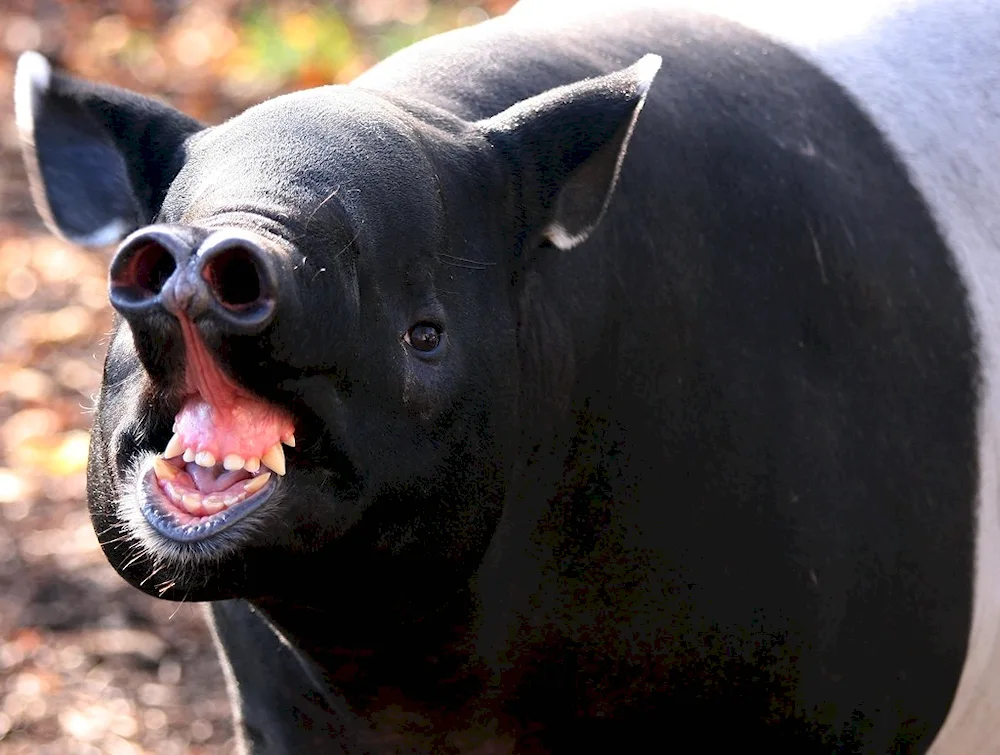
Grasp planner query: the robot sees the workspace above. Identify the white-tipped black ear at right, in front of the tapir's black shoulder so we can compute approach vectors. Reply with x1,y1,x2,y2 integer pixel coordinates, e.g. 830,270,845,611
477,55,662,250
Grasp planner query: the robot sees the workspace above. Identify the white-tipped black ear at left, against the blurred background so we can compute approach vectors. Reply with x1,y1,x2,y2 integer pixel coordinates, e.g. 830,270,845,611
14,52,203,246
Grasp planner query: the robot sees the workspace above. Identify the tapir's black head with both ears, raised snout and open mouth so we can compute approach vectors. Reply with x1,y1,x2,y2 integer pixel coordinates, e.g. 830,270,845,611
15,48,659,599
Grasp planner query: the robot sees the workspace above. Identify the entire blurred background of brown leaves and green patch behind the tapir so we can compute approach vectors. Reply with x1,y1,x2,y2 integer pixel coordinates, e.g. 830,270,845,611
0,0,513,755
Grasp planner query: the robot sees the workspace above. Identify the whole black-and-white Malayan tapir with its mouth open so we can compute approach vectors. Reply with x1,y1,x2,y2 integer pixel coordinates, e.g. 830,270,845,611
15,0,1000,755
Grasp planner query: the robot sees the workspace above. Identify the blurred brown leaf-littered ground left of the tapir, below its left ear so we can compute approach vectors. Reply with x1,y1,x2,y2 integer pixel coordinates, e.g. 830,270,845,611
0,71,240,755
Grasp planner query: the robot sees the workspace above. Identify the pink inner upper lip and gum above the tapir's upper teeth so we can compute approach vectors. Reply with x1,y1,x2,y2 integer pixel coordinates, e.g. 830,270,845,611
174,317,295,464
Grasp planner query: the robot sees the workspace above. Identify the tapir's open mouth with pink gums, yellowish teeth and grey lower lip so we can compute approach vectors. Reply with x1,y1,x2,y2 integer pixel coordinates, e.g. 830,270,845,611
139,321,295,542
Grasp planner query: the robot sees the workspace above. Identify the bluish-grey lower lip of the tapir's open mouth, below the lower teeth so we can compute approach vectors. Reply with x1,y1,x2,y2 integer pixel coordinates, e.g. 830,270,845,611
137,467,279,543
